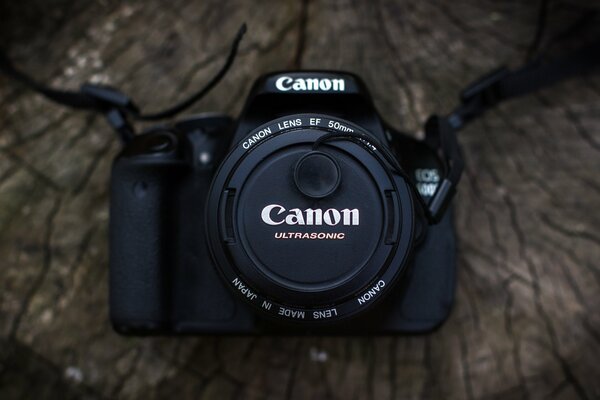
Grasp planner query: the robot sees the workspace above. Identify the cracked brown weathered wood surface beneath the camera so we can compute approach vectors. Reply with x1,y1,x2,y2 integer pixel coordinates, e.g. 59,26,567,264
0,0,600,399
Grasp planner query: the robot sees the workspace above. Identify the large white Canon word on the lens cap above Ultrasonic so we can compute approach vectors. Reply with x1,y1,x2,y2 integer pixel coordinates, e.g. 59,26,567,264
260,204,360,226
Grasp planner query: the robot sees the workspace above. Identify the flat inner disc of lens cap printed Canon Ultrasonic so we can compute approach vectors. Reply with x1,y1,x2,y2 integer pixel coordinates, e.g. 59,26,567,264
236,144,383,294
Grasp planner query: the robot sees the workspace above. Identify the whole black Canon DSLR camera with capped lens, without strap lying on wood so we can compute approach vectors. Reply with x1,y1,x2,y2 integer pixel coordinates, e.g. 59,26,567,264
110,71,456,335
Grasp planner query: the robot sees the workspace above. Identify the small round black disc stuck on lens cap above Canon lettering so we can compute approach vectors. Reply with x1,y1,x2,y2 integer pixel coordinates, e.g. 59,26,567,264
294,151,340,199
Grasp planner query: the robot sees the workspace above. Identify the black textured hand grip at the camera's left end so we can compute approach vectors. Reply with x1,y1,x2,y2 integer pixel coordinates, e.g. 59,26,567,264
110,156,183,333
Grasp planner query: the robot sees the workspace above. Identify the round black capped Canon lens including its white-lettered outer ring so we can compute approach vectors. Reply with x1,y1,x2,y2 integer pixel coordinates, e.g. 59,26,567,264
207,114,414,322
